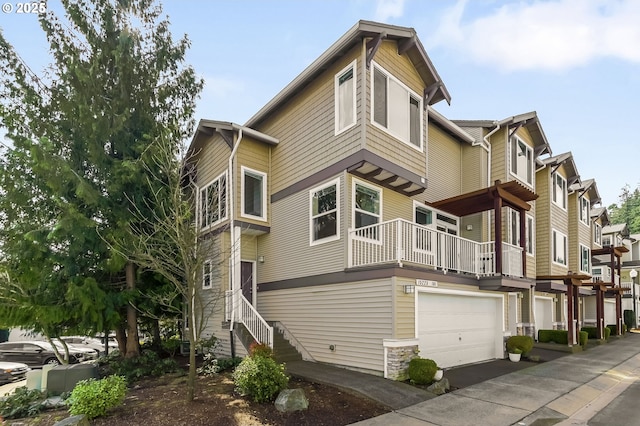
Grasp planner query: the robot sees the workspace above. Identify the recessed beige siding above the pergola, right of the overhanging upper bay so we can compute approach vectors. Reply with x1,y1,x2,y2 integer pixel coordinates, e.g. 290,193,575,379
425,124,462,202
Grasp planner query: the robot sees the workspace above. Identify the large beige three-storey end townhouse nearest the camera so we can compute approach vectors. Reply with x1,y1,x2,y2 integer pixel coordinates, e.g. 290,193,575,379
185,21,548,378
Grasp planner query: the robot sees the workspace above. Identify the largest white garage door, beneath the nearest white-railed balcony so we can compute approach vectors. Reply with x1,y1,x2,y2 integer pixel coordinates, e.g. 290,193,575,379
417,292,504,367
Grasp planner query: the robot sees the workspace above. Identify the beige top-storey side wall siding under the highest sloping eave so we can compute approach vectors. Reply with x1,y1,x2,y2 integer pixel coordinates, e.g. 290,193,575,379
257,47,363,193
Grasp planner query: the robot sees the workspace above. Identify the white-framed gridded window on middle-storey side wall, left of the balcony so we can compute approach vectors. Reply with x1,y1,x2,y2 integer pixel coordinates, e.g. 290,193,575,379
309,179,340,245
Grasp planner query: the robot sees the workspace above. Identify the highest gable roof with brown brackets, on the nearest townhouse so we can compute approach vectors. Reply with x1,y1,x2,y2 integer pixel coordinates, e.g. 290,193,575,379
245,20,451,128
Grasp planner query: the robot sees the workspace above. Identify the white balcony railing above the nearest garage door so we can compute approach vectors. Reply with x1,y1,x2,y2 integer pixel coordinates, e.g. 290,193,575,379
348,219,524,277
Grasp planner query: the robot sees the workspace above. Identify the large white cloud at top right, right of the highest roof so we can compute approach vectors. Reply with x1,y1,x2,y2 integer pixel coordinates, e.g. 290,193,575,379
426,0,640,71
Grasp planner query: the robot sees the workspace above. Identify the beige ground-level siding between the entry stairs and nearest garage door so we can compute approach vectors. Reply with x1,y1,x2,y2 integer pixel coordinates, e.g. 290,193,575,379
258,280,393,373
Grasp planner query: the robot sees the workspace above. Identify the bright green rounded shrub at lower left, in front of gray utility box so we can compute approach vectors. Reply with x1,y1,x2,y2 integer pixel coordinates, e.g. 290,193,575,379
67,376,127,419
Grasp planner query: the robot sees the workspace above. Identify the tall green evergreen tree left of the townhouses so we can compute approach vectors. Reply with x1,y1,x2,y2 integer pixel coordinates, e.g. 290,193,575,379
0,0,202,356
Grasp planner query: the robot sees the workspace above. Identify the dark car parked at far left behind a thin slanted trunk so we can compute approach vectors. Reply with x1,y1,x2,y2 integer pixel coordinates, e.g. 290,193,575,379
0,340,97,368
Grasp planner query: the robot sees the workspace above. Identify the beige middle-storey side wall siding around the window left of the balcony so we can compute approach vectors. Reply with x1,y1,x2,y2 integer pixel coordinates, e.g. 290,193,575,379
257,175,351,282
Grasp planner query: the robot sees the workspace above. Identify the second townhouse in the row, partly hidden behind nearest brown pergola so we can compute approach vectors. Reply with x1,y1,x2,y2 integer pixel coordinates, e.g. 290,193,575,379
454,111,551,337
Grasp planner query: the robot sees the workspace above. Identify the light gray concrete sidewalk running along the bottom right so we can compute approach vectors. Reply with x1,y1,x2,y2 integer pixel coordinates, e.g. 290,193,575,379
355,334,640,426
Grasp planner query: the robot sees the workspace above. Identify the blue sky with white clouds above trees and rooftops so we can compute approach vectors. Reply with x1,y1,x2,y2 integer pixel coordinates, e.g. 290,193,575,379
0,0,640,206
